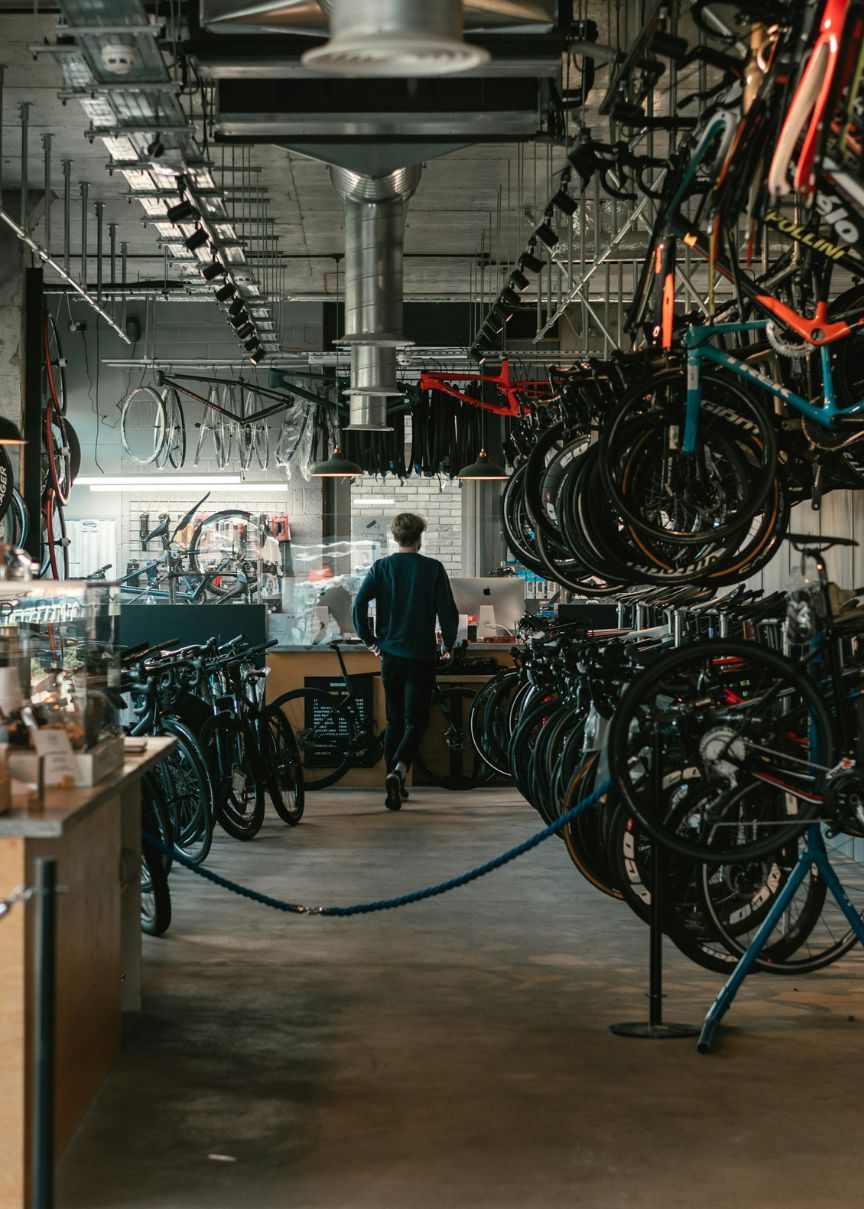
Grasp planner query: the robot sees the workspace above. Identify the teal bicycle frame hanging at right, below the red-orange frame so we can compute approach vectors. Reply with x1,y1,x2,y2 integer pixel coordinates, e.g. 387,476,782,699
682,319,864,453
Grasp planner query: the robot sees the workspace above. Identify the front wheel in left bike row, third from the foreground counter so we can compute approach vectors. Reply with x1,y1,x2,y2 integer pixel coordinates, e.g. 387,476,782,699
201,712,263,839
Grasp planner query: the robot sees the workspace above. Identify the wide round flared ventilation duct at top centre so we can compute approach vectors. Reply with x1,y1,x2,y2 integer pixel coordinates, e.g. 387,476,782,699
303,0,489,76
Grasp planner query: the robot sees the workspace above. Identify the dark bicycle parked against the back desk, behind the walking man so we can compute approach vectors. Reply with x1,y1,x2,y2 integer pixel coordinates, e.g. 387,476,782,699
269,642,493,789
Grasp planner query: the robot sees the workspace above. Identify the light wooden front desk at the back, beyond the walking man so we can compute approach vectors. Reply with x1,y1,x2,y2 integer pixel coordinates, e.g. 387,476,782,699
267,642,512,788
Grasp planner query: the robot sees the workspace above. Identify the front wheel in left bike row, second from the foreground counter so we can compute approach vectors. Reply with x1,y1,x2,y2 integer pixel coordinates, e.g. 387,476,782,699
155,716,216,864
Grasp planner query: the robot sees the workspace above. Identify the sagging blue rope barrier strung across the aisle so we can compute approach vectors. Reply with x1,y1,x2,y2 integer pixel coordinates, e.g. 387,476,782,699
144,781,611,919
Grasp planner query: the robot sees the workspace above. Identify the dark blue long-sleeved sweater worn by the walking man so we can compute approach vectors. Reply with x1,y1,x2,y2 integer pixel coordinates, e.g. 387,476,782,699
353,553,459,659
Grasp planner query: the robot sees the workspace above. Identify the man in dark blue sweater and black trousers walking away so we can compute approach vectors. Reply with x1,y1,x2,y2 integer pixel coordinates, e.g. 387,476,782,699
353,513,459,810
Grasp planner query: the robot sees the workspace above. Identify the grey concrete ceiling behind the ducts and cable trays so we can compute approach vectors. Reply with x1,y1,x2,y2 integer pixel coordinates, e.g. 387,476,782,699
0,0,715,343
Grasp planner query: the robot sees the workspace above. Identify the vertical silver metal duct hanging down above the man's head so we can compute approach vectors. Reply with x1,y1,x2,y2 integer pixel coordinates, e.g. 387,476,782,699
330,164,421,430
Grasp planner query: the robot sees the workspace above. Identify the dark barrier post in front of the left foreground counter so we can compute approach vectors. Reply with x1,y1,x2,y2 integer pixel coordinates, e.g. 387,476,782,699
33,857,57,1209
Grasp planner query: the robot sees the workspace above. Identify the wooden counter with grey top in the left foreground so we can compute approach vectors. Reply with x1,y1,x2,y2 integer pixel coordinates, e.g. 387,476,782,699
0,739,174,1209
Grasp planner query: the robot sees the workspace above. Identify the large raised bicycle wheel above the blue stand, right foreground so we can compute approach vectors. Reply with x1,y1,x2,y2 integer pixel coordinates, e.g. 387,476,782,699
609,640,833,863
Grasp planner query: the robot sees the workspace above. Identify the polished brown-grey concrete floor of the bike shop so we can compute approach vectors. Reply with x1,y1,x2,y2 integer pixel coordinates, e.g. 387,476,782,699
57,791,864,1209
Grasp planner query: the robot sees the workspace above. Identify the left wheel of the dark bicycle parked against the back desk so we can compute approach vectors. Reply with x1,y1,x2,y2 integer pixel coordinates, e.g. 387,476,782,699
267,688,355,789
